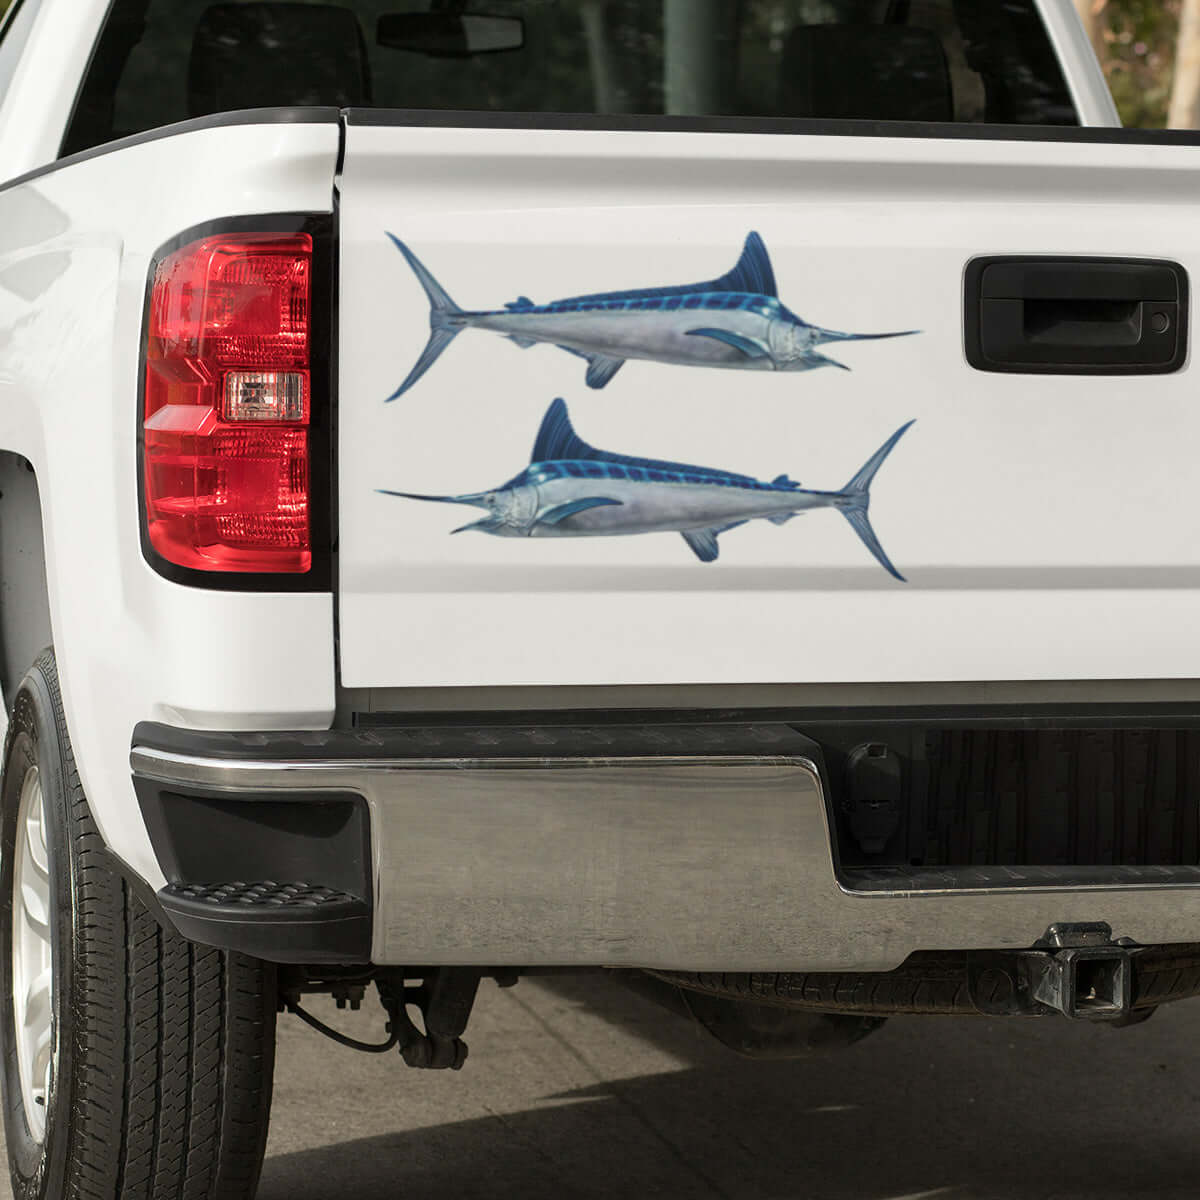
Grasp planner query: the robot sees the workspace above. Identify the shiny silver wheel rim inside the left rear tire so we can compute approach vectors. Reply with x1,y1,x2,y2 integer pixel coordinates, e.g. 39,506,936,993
12,767,55,1141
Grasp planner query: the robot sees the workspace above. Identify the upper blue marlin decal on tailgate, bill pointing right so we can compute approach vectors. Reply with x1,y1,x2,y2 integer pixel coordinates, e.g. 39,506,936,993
388,233,919,400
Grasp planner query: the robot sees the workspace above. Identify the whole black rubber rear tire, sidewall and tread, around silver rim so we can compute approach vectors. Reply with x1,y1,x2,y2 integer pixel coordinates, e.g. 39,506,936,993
0,650,275,1200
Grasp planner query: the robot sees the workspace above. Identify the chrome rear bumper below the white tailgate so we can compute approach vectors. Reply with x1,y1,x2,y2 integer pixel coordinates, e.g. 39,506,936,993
131,731,1200,972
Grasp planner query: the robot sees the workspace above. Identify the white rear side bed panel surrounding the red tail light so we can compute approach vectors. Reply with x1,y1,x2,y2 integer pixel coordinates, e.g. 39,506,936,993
0,124,338,886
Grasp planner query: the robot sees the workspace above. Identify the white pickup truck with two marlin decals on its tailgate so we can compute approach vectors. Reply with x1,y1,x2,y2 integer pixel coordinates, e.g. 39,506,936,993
0,0,1200,1200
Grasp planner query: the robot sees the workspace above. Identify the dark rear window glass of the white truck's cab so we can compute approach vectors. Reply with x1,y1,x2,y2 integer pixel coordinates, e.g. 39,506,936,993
65,0,1078,152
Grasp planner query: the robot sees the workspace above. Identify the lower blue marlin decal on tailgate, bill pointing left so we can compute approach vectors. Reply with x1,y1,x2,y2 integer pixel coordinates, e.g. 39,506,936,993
378,400,913,583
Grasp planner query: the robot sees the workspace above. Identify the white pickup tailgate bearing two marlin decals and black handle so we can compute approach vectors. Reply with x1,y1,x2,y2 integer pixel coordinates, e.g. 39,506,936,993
338,113,1200,686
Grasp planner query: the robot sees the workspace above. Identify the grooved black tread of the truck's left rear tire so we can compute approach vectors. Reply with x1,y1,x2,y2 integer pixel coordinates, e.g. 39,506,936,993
2,650,275,1200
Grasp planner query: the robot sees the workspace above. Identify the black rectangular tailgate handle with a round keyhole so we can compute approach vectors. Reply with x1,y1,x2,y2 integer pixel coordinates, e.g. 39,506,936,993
965,258,1188,374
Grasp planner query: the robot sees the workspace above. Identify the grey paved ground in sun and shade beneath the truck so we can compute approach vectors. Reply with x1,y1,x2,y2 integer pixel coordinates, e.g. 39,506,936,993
2,978,1200,1200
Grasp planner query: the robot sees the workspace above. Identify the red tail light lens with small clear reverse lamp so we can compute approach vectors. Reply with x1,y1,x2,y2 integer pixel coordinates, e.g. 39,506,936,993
143,234,312,574
